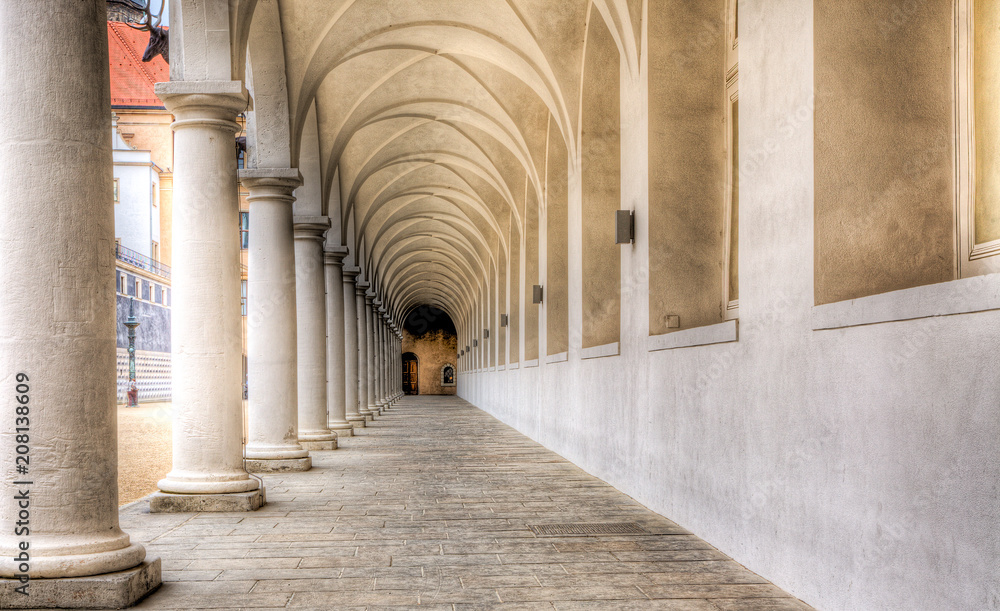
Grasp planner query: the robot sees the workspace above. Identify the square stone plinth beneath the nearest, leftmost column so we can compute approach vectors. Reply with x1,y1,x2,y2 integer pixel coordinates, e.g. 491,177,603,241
0,558,161,609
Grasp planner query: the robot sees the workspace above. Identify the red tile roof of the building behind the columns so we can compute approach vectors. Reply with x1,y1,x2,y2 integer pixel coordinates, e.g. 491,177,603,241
108,21,170,108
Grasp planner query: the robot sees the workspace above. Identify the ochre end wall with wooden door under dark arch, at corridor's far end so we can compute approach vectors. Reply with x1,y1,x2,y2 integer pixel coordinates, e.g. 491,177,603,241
403,305,458,395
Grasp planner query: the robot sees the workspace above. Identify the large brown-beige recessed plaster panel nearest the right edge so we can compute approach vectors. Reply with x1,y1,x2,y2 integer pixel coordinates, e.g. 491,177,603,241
816,0,956,304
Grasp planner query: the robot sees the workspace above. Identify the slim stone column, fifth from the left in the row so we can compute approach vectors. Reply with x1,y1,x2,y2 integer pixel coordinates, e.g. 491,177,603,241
325,246,354,439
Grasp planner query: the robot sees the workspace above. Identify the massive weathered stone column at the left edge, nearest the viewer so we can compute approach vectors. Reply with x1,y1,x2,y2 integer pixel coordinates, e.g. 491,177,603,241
0,0,160,609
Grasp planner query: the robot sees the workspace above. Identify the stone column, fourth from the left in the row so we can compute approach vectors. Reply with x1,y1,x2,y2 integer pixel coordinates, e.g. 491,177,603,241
292,216,337,450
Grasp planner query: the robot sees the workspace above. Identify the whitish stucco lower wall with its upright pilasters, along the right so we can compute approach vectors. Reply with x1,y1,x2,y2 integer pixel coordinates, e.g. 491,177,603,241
459,0,1000,611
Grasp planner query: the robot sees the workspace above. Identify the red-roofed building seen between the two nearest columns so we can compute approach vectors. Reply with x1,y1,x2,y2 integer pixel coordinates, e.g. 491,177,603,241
107,19,173,403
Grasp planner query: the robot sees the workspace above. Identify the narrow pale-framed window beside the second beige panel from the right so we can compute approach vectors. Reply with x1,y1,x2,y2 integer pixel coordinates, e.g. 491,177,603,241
722,0,740,320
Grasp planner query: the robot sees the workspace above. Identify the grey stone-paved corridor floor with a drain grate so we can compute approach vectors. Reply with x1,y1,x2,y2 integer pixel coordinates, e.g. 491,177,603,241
115,397,810,611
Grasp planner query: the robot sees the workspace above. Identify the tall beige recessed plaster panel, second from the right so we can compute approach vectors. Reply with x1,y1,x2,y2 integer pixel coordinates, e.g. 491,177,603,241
649,0,727,335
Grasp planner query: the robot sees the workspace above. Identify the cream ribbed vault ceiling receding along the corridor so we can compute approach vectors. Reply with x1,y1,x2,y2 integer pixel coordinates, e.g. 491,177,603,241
232,0,642,338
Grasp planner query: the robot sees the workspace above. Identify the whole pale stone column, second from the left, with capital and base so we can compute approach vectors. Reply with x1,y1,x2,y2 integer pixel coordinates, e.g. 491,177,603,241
150,81,263,512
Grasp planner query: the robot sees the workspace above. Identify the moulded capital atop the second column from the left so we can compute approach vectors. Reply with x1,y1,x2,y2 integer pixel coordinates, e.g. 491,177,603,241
154,81,249,134
